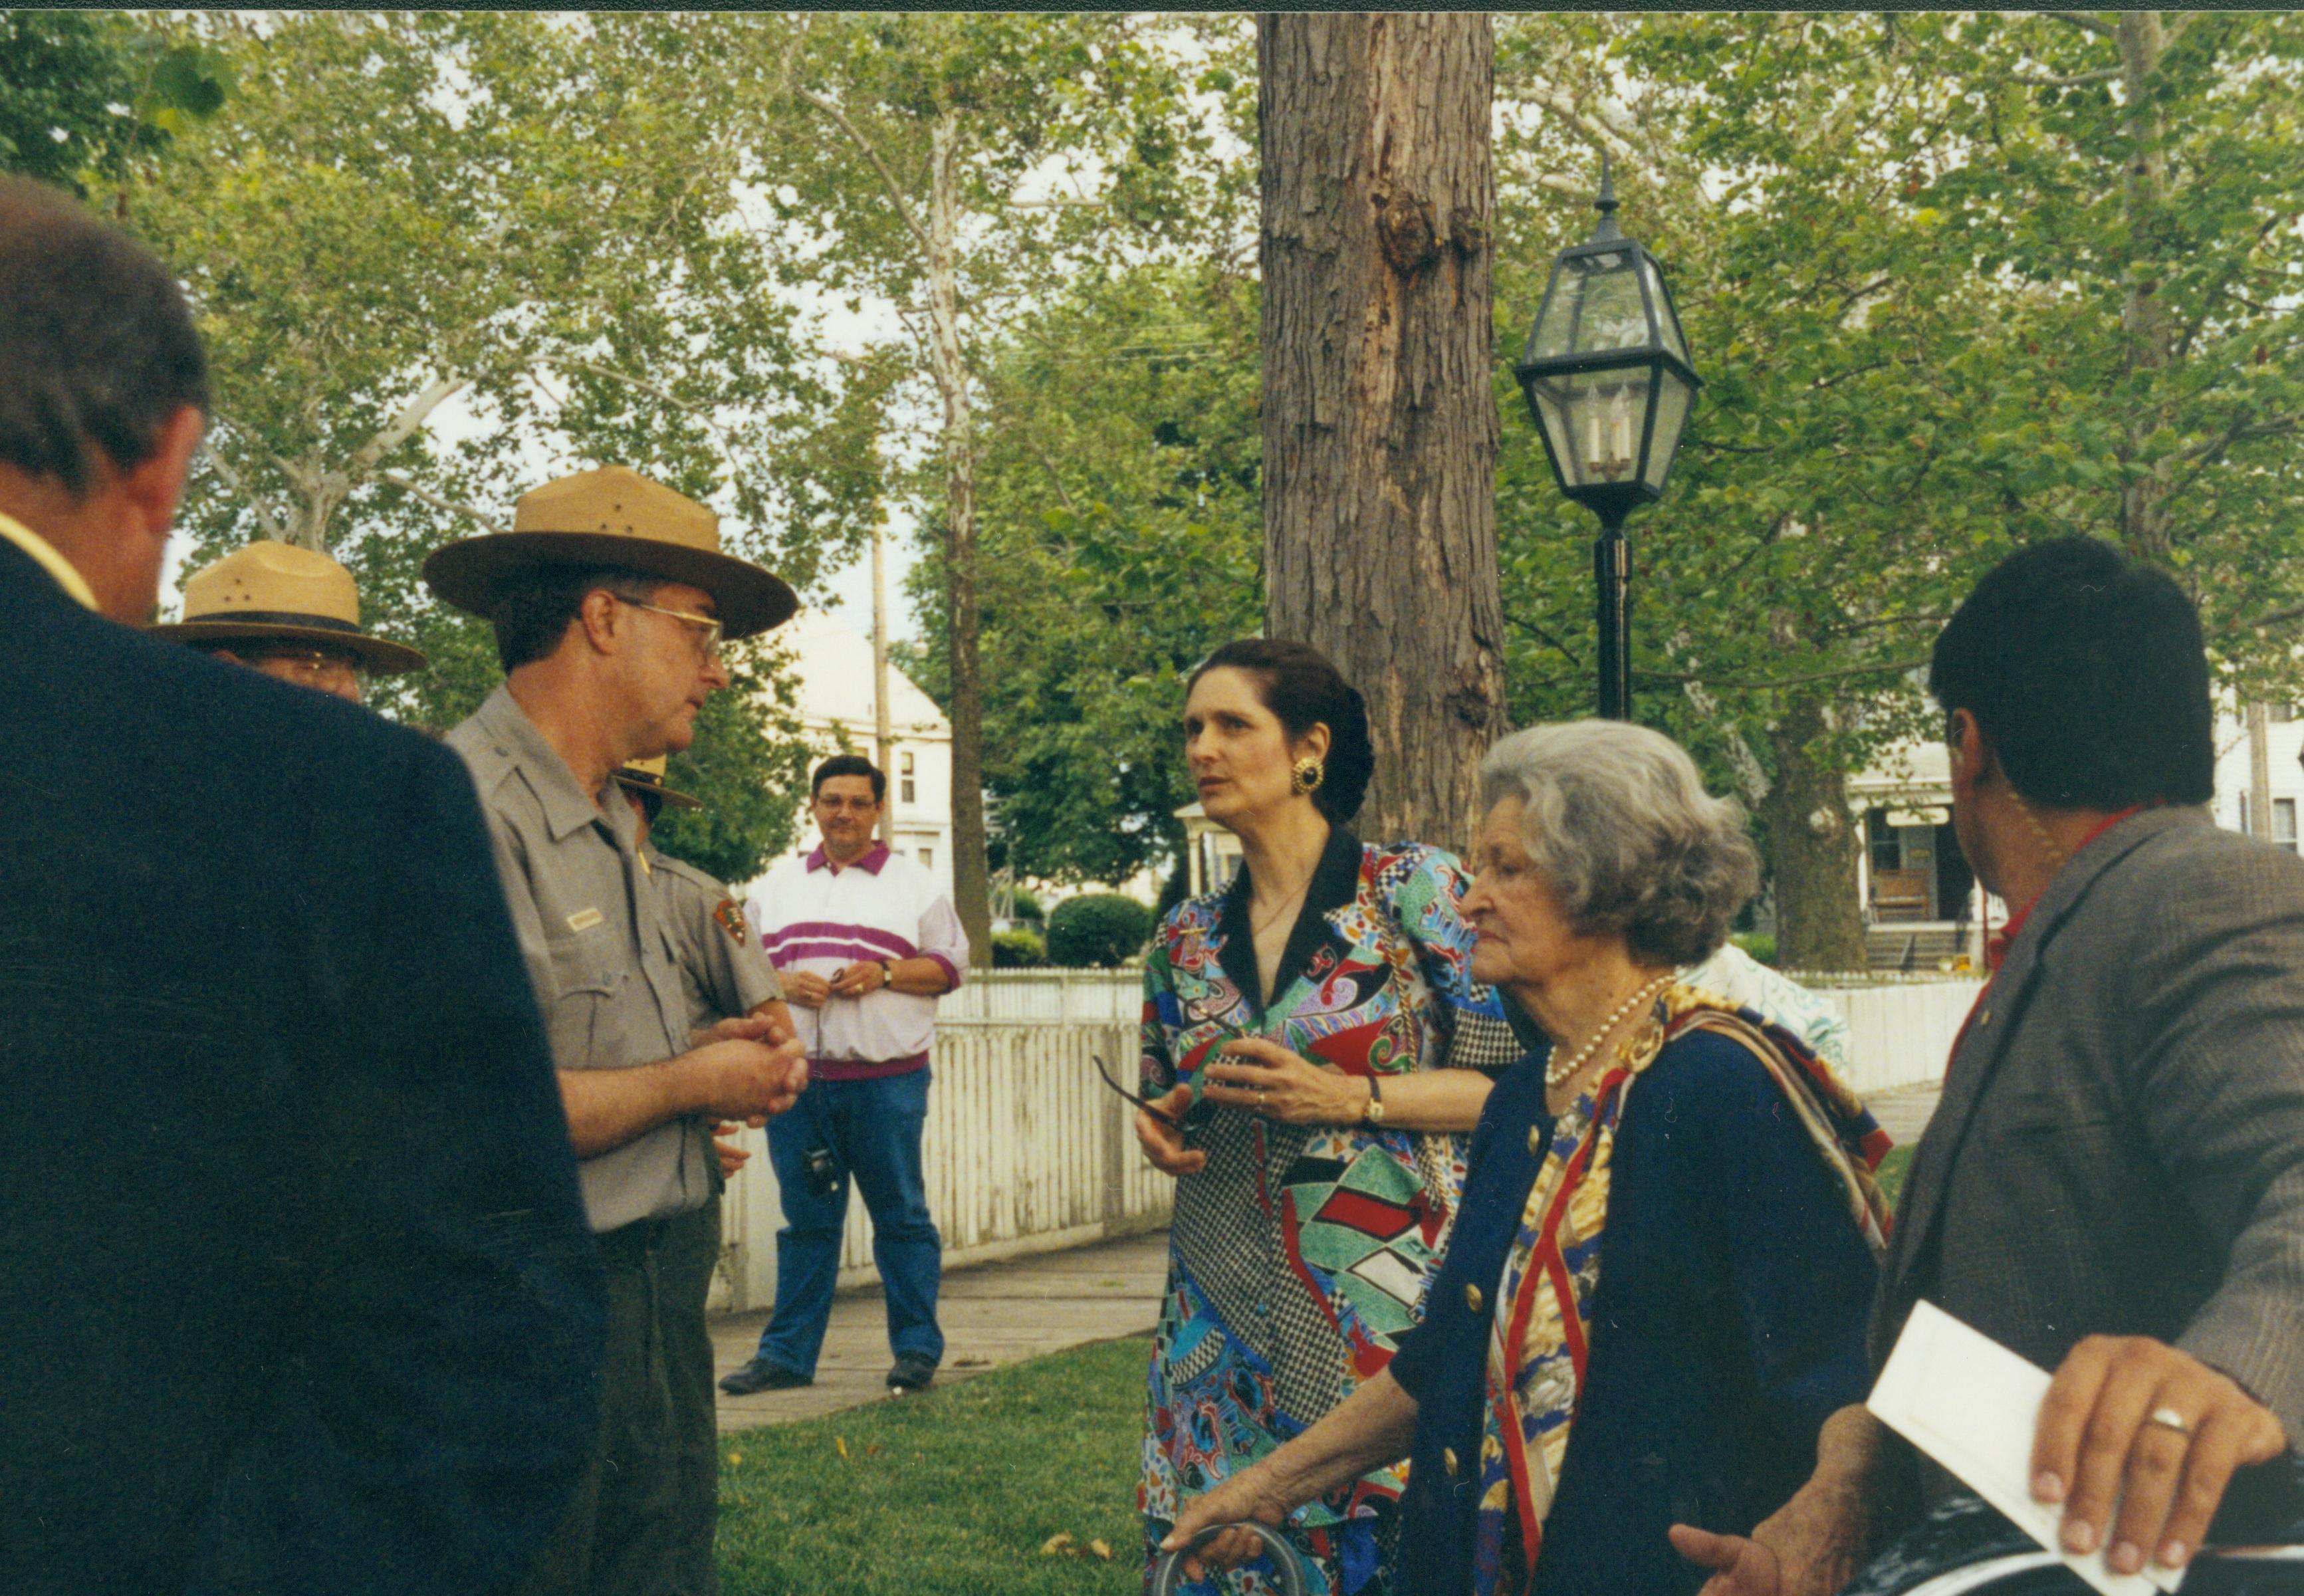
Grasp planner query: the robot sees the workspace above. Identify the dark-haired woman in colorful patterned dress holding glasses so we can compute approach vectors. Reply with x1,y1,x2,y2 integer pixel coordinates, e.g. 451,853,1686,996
1138,640,1518,1596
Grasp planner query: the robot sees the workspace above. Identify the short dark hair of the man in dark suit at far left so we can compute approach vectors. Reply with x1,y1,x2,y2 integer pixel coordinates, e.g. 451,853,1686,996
0,177,209,497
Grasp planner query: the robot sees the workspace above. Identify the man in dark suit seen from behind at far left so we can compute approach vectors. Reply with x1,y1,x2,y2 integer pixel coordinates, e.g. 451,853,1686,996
0,179,602,1596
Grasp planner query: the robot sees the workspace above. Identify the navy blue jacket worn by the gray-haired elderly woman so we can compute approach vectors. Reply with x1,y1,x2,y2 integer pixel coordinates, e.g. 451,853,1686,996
1391,1032,1878,1596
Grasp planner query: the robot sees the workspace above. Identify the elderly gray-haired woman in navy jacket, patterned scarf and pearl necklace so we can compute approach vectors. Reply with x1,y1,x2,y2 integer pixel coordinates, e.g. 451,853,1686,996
1166,721,1887,1596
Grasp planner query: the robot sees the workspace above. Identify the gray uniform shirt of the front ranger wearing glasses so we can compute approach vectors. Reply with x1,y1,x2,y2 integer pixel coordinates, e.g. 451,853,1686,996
447,686,717,1232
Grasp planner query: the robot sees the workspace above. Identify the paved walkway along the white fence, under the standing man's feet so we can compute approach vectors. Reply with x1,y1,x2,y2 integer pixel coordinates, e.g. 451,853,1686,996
712,1230,1168,1432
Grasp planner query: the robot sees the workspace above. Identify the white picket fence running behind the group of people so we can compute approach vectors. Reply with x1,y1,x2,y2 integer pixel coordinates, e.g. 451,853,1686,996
717,970,1979,1308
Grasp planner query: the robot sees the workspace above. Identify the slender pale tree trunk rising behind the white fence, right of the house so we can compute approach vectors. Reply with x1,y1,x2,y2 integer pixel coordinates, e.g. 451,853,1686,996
929,110,993,970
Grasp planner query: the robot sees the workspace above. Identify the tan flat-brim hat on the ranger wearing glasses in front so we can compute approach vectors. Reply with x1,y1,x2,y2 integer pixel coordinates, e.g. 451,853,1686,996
424,465,800,638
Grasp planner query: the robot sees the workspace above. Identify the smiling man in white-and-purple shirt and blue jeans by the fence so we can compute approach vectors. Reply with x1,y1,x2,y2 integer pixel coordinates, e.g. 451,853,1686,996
721,753,968,1396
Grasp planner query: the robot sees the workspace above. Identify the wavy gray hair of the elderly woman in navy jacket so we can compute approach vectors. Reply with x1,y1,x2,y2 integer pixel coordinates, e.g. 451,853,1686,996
1479,721,1760,965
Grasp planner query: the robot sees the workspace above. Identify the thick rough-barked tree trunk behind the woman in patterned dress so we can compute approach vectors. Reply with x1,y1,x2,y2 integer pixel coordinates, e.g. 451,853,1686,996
1256,11,1504,848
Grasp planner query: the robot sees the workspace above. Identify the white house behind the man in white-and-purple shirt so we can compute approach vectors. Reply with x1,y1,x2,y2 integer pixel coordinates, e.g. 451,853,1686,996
737,610,951,896
